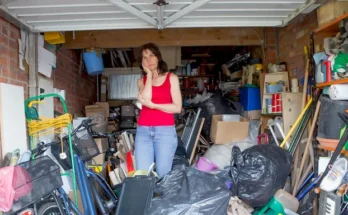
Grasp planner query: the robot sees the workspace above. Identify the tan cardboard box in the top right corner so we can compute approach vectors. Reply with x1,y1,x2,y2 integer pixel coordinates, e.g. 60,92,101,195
317,0,348,26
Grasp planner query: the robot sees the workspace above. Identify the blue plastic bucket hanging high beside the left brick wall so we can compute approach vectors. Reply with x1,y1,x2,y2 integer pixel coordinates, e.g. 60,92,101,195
83,51,104,75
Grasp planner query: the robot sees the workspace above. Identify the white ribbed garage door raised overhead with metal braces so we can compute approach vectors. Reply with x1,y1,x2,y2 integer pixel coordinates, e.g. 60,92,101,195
1,0,314,32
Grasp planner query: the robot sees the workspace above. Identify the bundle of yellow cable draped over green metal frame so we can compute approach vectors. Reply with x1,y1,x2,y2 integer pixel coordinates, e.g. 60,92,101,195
28,113,72,136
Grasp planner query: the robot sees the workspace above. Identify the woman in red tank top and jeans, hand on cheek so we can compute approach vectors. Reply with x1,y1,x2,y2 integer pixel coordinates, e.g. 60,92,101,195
135,43,182,177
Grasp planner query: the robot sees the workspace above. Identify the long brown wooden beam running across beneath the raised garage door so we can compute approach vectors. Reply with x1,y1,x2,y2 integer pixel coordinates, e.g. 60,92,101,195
64,28,263,49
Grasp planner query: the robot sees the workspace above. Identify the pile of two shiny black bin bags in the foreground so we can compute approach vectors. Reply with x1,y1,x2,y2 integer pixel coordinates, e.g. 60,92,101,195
147,145,291,215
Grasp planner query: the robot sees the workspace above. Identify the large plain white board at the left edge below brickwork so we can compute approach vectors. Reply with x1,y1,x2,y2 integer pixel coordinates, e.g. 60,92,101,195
0,83,28,158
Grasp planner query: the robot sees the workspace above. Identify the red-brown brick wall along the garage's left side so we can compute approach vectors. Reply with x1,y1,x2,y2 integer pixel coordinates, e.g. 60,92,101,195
0,17,97,114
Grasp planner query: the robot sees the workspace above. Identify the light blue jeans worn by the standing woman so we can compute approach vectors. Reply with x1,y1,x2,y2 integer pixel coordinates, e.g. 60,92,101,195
135,126,178,177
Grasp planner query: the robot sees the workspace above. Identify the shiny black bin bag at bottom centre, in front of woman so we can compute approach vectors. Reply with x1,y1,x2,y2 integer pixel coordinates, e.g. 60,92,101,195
146,165,230,215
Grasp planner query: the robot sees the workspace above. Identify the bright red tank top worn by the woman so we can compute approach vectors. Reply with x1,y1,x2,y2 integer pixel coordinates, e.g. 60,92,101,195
138,72,175,126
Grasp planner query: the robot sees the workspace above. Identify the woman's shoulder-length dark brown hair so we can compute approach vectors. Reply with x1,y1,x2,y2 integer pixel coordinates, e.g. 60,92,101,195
138,43,168,75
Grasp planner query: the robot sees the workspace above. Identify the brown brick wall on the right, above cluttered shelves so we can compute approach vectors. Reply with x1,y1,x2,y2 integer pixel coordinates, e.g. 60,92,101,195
278,10,318,79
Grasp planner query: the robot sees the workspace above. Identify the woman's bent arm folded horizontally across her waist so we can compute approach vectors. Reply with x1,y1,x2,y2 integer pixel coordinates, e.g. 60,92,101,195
150,74,182,113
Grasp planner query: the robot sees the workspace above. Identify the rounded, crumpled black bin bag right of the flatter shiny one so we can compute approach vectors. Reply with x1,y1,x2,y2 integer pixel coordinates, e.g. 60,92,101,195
230,144,291,208
